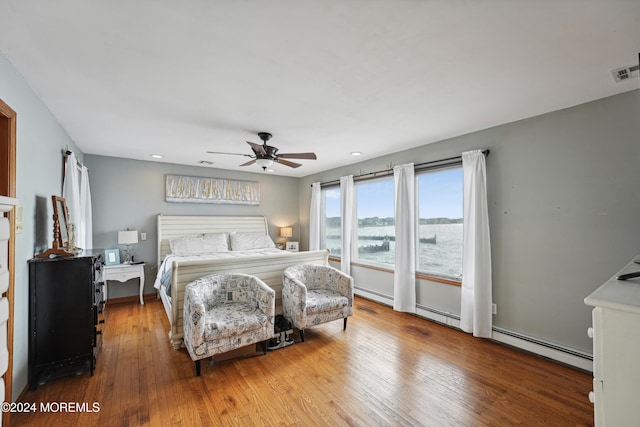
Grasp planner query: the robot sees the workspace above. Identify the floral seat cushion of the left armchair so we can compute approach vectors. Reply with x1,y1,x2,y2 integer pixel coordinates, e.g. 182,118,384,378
204,302,268,341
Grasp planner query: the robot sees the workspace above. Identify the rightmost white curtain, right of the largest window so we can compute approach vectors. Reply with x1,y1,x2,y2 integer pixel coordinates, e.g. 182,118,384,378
460,150,492,338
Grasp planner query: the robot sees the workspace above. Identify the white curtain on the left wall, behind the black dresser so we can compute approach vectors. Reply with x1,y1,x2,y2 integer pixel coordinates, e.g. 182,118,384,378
62,153,93,249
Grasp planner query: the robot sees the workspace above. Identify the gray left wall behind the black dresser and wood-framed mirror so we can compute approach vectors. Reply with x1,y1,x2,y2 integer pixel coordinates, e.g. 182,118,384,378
0,53,82,400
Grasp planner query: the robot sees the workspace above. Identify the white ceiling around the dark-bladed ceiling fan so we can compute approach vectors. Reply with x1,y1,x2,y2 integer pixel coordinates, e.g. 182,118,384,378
0,0,640,177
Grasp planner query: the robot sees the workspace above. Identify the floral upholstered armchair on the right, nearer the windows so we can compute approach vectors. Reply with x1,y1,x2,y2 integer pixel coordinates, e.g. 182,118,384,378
282,264,353,342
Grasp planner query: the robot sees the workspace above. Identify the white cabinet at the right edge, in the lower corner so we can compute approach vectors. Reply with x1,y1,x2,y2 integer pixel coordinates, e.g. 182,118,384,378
584,262,640,427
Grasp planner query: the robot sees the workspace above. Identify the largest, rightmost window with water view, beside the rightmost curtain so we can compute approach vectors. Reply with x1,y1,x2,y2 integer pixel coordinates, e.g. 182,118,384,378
416,167,463,281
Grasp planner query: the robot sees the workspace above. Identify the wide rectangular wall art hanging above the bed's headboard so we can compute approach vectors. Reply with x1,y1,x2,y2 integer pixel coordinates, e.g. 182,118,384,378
165,175,260,205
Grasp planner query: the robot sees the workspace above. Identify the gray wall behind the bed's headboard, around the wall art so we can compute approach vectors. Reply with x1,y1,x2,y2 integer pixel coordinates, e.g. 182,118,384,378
85,155,300,298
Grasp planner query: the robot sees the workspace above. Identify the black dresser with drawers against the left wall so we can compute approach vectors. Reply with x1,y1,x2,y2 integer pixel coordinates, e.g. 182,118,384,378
29,250,104,390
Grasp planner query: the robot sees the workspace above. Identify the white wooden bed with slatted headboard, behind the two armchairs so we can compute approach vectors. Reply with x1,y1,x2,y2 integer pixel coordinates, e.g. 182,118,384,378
154,215,329,349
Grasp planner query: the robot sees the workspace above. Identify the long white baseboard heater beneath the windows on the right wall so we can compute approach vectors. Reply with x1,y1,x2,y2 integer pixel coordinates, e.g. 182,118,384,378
355,287,593,372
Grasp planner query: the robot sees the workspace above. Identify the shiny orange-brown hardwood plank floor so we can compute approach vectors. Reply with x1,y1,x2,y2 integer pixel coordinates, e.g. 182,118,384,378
12,298,593,427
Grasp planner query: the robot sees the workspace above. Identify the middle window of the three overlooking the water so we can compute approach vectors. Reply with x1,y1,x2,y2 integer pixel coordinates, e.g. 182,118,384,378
354,177,395,268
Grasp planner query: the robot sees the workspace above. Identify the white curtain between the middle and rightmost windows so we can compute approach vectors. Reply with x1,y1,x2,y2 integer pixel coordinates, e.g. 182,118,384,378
393,163,416,313
